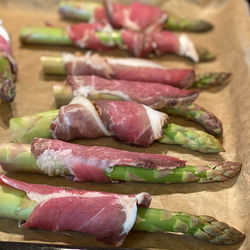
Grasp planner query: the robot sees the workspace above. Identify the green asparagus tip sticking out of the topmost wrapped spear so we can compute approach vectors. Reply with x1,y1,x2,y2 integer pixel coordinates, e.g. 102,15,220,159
164,16,213,32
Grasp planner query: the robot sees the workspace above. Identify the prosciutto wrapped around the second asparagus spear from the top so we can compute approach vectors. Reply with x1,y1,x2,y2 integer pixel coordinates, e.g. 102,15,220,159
68,23,199,62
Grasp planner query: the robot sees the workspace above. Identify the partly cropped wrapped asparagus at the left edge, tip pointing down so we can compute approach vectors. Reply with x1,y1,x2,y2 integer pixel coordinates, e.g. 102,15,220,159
0,20,17,102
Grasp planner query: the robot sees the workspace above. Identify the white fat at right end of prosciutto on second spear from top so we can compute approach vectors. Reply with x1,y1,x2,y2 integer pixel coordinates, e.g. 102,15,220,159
179,34,199,62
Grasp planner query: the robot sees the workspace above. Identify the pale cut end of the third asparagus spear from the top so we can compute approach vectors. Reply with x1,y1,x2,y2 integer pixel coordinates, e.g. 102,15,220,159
40,56,66,75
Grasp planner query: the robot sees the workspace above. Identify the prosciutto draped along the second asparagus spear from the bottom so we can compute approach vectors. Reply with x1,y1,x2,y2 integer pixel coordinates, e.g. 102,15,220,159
31,138,185,182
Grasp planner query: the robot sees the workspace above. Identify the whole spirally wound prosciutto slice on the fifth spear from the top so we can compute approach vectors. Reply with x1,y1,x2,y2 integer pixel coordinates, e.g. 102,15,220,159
50,96,168,146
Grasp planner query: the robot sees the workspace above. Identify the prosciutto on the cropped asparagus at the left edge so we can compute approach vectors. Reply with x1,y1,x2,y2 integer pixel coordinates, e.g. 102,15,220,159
0,20,17,75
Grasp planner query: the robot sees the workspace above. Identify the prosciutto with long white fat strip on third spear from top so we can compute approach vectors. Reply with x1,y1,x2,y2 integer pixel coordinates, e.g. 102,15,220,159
63,53,195,88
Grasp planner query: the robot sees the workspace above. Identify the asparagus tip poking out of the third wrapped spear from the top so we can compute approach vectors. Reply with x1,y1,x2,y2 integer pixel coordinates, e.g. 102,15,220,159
191,72,231,89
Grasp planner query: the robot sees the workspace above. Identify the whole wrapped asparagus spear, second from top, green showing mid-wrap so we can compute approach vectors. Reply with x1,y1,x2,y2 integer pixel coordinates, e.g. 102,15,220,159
20,23,215,63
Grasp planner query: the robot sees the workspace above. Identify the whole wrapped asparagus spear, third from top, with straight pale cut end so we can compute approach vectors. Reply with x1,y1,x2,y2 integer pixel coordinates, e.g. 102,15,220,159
41,53,230,88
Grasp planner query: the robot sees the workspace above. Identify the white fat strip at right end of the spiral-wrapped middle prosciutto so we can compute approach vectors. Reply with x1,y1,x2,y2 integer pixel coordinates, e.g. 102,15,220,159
143,105,168,140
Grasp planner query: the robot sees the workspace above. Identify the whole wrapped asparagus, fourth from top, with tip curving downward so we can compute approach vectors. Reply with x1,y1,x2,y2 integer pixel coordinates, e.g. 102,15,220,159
53,76,223,136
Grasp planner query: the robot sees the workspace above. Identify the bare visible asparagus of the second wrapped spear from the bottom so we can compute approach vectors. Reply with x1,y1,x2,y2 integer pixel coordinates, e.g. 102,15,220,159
0,143,241,184
